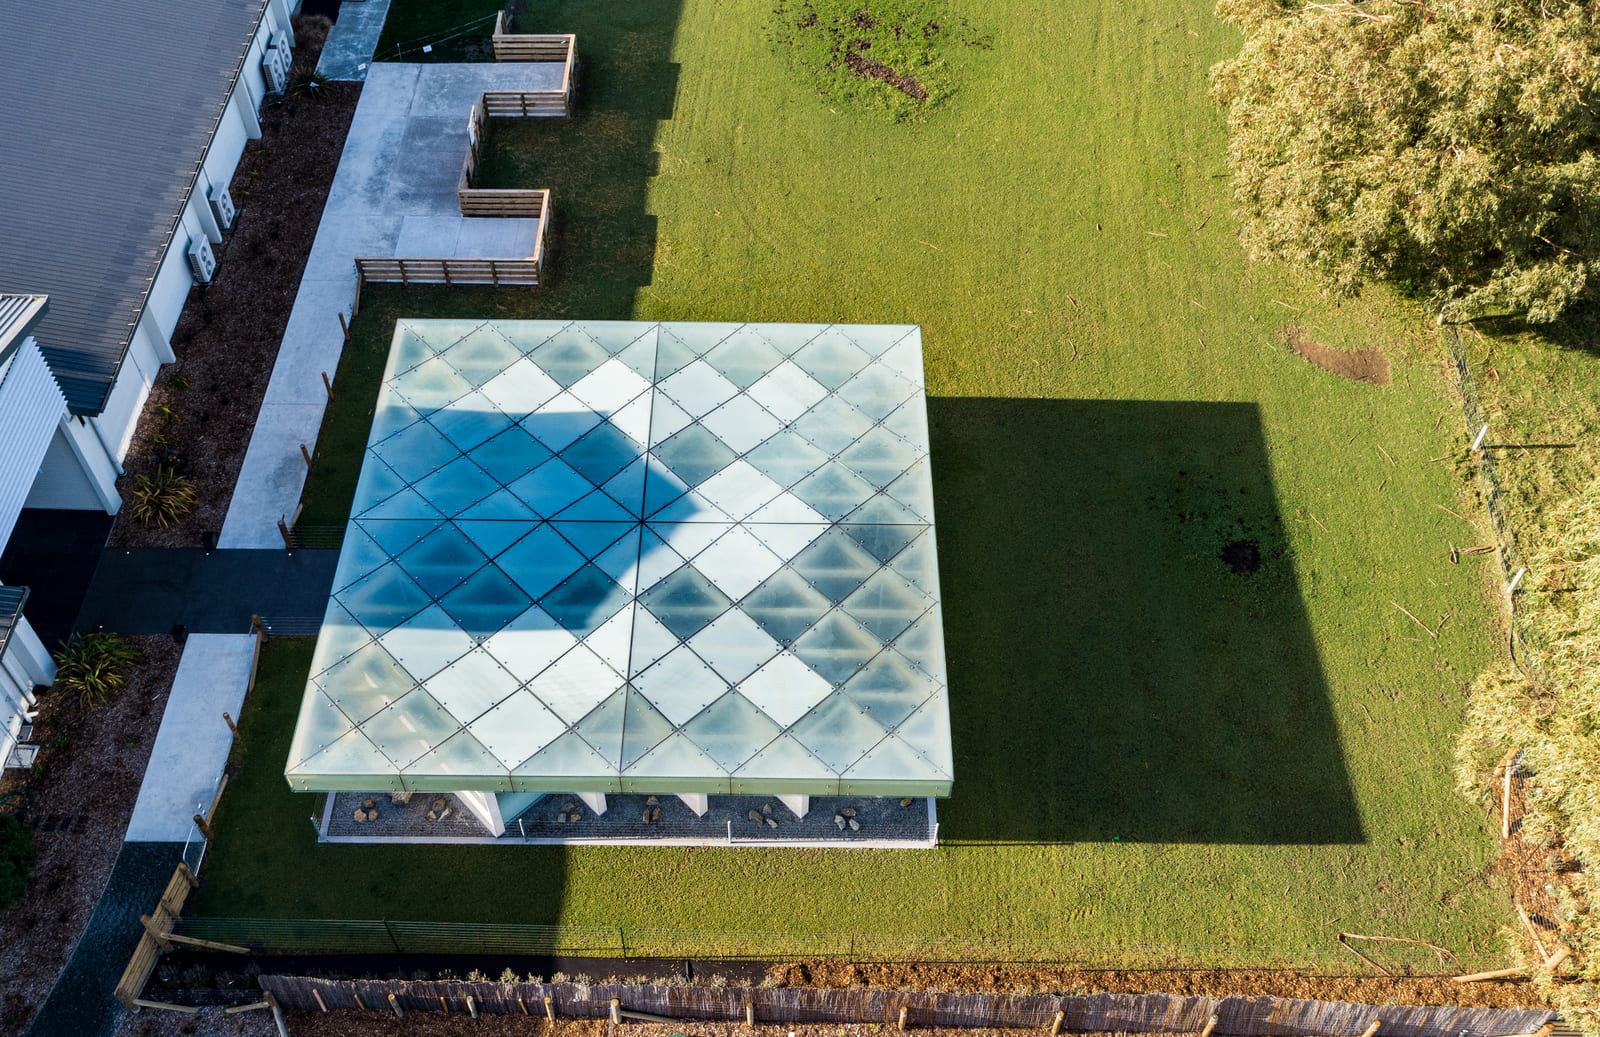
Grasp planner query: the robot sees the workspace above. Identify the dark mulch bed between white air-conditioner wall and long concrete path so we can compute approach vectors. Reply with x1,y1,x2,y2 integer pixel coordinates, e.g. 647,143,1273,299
110,18,362,547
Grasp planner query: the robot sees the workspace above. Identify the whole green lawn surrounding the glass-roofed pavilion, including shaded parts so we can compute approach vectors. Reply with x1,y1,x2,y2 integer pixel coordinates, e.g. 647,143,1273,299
197,0,1509,965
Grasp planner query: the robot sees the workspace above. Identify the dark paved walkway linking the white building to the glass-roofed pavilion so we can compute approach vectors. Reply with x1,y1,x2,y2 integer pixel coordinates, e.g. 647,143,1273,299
78,550,339,634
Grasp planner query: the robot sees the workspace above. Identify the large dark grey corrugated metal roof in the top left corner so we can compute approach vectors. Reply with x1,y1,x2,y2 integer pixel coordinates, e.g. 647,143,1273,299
0,0,266,414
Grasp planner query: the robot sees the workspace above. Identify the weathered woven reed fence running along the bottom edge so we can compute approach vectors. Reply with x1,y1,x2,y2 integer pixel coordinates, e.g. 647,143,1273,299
261,976,1555,1037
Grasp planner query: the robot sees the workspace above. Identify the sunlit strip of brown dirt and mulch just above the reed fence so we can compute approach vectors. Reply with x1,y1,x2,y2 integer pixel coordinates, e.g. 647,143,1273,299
768,960,1546,1008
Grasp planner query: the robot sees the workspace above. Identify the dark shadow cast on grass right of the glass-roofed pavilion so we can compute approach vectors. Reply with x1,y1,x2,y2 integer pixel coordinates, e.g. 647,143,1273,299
928,398,1363,843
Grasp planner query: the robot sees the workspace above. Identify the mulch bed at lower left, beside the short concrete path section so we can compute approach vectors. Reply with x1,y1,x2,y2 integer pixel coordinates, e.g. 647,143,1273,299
0,637,181,1034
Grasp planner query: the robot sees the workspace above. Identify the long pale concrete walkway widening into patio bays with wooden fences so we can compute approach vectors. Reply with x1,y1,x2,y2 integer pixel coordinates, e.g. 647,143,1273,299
218,61,562,547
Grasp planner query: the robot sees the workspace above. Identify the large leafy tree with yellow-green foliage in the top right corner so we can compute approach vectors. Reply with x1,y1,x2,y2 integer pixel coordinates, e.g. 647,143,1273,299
1211,0,1600,323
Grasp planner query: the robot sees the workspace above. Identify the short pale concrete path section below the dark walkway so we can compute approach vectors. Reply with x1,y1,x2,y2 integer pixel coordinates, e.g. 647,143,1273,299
126,634,256,843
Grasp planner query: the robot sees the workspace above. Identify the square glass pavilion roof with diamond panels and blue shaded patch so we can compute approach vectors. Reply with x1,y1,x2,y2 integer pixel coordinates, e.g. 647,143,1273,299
286,320,954,795
